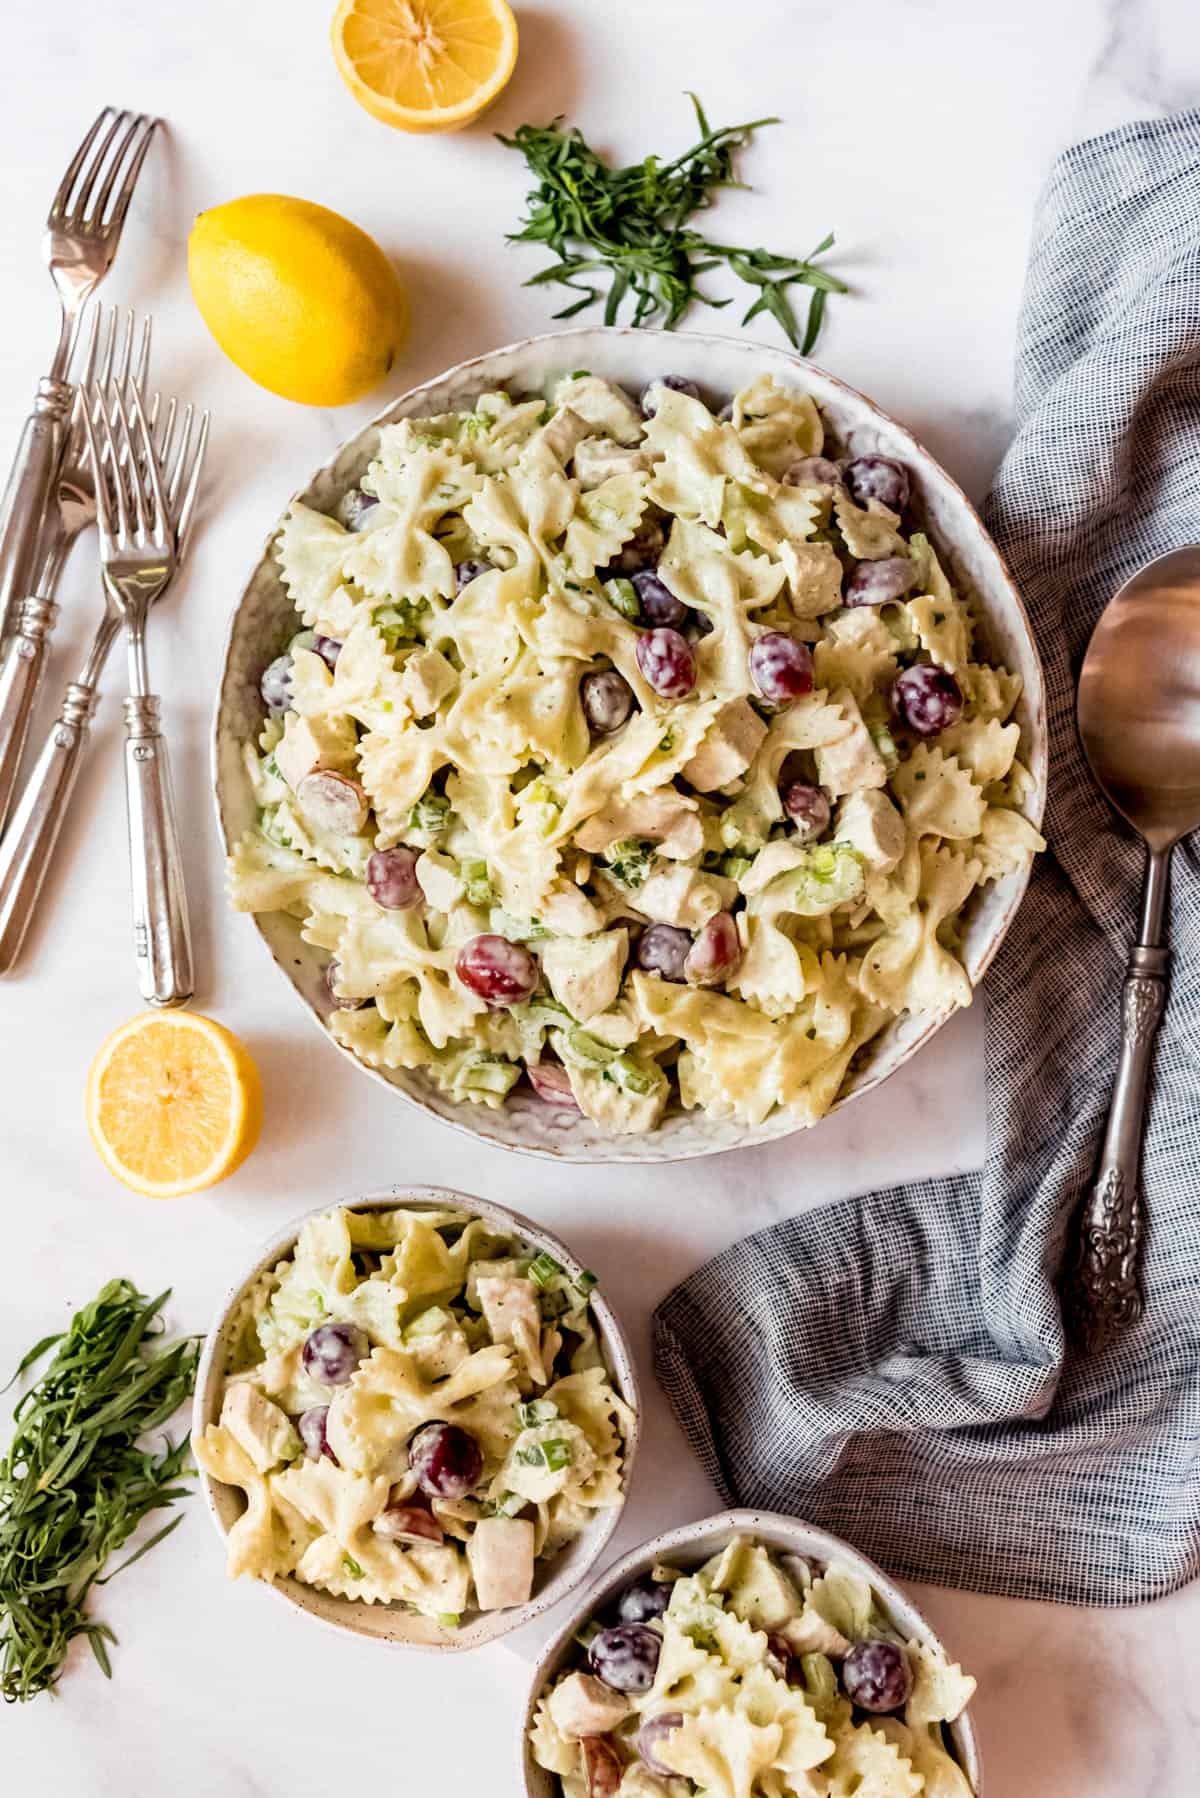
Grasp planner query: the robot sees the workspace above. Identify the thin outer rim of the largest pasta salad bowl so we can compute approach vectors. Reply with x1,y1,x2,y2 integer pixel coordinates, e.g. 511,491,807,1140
209,325,1049,1167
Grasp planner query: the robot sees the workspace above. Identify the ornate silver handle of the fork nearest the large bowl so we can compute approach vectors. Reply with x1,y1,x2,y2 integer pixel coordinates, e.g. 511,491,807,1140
124,694,194,1005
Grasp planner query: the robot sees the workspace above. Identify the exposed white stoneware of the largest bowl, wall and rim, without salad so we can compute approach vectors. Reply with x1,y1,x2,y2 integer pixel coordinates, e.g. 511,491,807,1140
214,327,1045,1162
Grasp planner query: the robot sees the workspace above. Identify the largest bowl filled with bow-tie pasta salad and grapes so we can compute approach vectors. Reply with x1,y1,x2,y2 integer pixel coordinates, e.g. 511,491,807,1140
216,329,1045,1160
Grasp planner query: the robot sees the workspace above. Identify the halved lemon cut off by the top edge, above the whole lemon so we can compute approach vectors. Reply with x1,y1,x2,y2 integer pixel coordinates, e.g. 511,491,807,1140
333,0,516,131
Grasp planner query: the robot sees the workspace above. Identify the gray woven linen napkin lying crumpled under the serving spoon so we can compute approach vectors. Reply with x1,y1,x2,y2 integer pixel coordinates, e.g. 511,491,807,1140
655,111,1200,1604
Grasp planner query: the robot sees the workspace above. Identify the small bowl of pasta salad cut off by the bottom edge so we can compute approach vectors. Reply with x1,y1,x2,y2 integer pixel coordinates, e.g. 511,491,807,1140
518,1510,982,1798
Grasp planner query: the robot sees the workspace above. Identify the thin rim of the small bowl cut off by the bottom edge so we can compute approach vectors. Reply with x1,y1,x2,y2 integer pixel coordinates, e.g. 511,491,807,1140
516,1507,982,1798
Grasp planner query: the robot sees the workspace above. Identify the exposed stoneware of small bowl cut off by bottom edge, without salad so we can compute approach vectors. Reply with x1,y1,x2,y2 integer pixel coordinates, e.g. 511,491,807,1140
516,1510,982,1798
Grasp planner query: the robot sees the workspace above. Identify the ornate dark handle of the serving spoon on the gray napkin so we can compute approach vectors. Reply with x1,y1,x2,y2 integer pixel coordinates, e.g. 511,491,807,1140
1067,944,1171,1349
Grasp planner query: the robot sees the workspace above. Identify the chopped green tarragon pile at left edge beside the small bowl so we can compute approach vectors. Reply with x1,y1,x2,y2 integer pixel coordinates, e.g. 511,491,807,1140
0,1280,200,1703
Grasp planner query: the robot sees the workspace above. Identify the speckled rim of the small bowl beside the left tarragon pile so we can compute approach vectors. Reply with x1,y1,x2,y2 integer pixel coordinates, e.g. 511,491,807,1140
191,1181,642,1652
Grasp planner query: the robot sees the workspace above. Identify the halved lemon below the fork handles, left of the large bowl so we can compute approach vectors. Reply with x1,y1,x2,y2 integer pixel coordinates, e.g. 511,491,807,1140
88,1012,263,1199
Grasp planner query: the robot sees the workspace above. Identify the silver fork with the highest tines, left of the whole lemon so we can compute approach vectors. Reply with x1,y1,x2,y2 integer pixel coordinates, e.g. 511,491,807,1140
0,106,158,635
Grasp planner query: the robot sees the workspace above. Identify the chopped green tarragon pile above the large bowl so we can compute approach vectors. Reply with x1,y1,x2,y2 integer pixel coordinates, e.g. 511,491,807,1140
500,93,849,356
